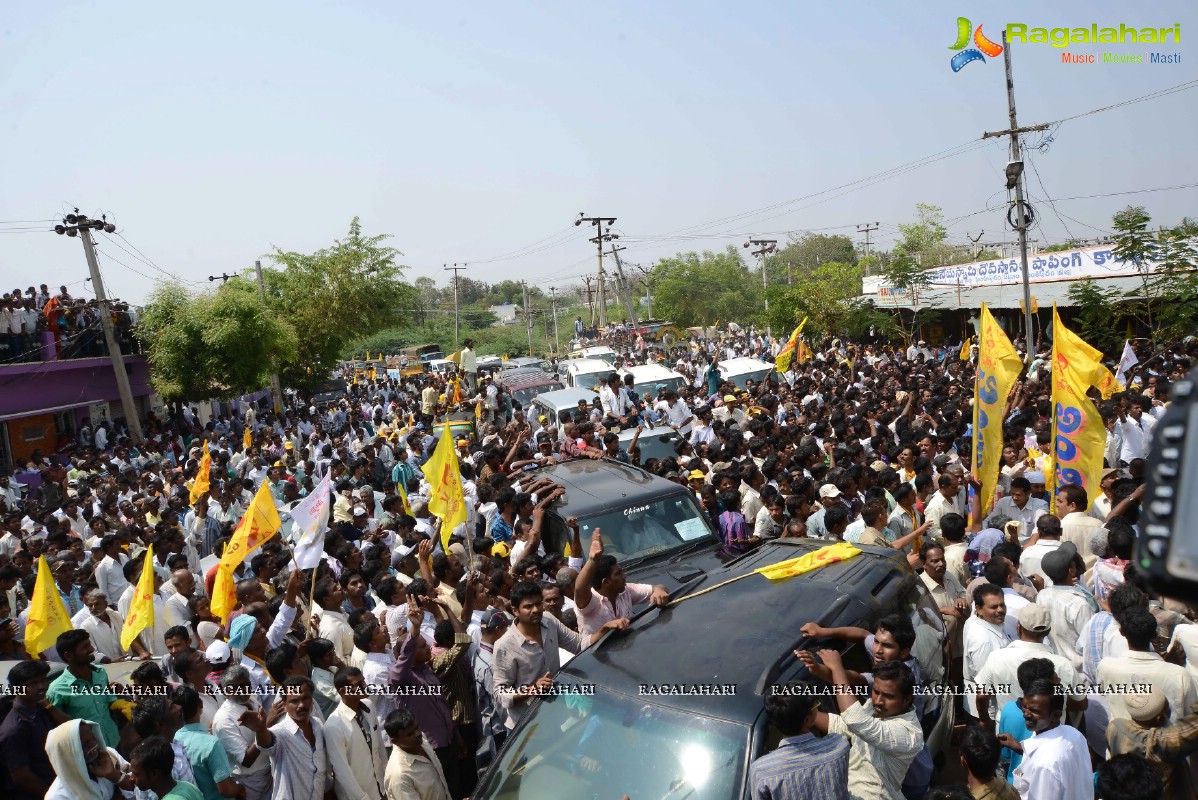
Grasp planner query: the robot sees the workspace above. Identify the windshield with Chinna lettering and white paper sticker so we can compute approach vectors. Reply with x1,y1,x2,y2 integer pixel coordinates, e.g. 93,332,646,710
579,492,714,563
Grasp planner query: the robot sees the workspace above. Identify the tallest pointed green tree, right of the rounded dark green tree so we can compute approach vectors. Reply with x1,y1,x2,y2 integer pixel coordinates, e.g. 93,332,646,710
266,217,414,387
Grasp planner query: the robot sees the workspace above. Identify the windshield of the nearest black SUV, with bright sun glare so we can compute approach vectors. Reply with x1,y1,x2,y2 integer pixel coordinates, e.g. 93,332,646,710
471,677,750,800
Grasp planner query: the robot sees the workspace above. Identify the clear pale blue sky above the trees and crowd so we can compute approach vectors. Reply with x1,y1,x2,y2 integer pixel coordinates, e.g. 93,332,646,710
0,0,1198,301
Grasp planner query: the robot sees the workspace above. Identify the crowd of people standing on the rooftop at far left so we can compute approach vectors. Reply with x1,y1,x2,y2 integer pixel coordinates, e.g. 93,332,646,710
0,284,140,364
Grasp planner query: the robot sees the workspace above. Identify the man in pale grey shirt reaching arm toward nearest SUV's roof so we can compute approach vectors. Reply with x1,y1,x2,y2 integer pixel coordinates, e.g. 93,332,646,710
491,581,628,729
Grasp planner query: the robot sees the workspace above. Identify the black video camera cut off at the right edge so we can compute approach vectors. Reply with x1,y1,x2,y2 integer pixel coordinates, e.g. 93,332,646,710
1135,371,1198,601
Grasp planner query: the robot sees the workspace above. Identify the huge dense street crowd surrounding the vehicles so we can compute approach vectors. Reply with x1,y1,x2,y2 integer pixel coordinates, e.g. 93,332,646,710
0,320,1198,800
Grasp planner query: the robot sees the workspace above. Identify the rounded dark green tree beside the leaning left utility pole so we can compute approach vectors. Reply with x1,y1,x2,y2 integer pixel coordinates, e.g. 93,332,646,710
137,278,298,402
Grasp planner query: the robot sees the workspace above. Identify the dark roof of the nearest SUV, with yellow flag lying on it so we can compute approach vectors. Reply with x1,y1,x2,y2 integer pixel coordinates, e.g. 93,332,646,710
562,539,914,723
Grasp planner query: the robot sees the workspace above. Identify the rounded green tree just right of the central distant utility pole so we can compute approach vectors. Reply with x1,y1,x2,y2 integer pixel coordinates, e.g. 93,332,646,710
646,246,762,327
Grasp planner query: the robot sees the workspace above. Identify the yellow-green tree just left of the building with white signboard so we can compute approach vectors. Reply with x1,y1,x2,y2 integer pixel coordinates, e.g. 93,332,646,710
766,262,894,339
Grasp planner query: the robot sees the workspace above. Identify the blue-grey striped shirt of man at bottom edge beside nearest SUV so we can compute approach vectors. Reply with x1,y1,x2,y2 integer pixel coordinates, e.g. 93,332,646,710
749,733,848,800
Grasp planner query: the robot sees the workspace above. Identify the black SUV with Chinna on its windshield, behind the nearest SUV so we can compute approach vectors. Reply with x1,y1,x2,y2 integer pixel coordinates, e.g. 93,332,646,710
534,459,724,589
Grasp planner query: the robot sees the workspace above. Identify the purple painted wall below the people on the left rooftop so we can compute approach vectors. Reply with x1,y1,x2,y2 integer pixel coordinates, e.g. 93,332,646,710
0,356,151,417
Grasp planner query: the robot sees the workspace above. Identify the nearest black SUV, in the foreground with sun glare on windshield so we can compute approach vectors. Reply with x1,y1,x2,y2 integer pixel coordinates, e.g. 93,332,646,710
471,539,919,800
